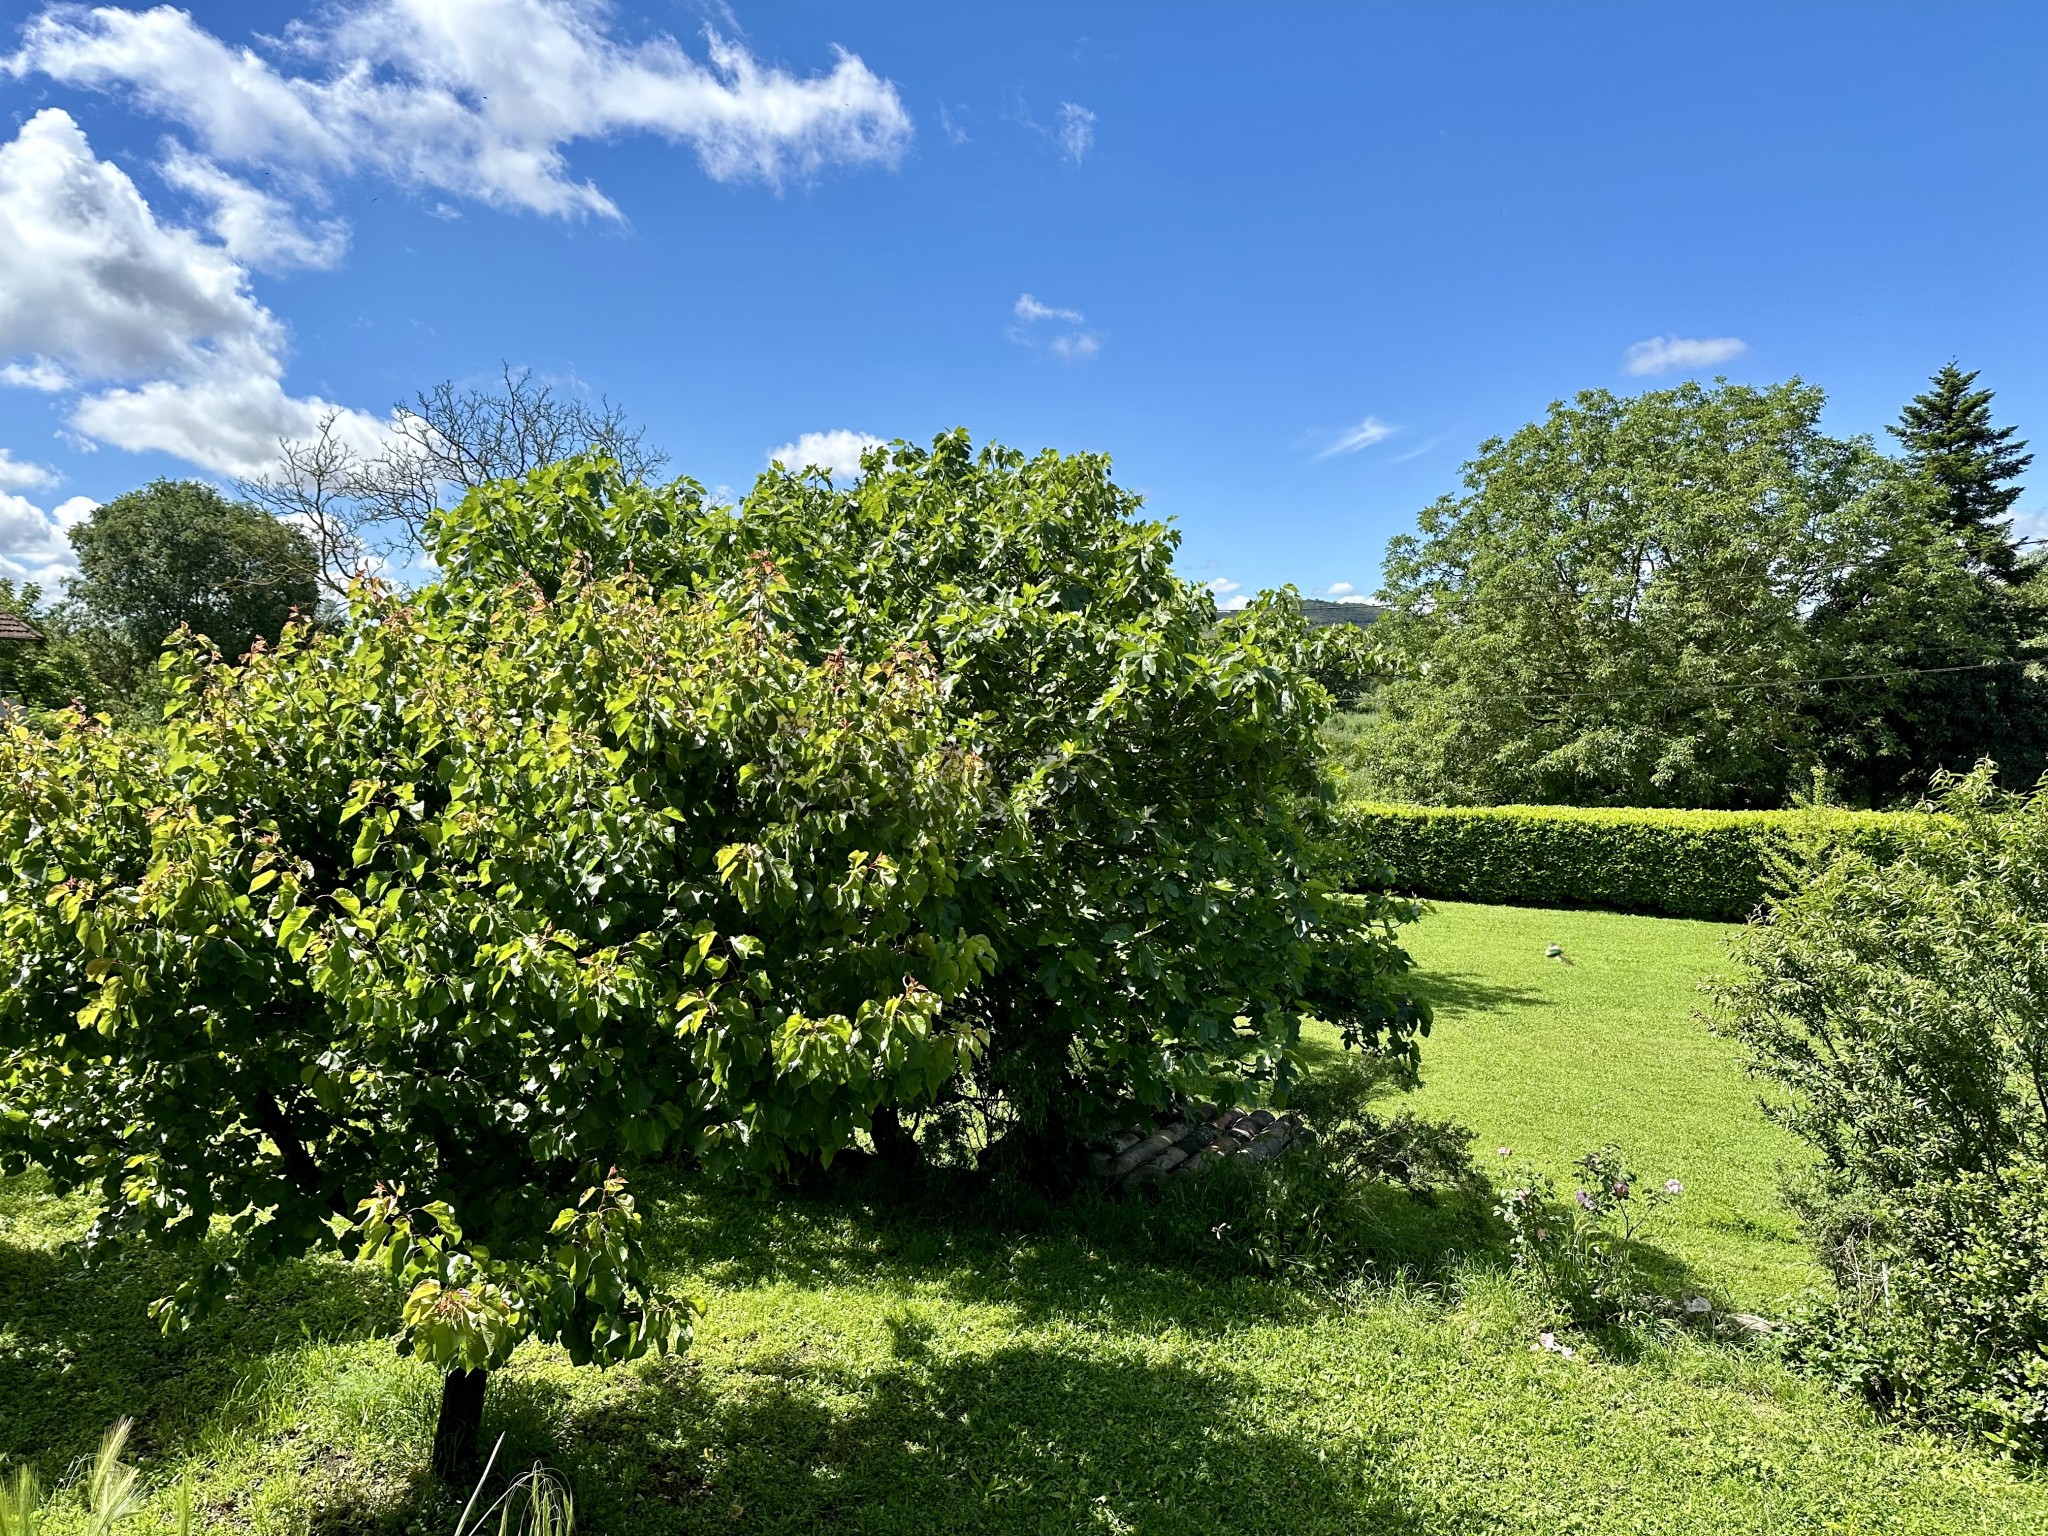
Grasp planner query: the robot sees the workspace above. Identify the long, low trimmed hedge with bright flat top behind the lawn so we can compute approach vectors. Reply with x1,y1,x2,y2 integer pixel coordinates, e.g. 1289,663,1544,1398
1331,803,1933,922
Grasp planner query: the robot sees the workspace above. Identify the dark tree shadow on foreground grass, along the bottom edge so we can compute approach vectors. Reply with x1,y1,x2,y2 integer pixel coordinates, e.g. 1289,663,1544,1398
473,1319,1452,1536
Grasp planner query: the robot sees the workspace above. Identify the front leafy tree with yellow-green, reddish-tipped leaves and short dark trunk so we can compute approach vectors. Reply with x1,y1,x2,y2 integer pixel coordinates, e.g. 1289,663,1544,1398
0,569,989,1473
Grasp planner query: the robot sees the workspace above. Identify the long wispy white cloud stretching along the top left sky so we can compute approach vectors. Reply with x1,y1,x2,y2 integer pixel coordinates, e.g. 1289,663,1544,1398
4,0,911,217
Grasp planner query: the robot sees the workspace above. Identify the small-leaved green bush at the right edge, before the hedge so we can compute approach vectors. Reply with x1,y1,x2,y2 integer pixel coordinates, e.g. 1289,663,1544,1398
1718,768,2048,1456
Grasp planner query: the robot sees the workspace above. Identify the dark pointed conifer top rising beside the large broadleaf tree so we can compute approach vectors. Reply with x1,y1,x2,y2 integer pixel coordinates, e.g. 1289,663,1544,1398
1886,362,2034,584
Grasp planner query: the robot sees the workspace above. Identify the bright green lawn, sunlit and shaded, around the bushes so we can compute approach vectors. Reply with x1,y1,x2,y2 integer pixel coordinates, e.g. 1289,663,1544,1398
0,905,2048,1536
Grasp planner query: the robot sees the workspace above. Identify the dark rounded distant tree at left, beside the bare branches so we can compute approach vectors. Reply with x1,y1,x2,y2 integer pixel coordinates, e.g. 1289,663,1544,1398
70,479,319,682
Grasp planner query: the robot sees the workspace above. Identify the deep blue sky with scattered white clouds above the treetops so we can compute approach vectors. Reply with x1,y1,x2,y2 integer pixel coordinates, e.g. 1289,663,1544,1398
0,0,2048,594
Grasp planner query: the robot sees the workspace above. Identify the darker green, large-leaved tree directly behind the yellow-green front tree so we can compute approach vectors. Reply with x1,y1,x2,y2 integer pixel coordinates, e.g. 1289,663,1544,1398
428,432,1425,1167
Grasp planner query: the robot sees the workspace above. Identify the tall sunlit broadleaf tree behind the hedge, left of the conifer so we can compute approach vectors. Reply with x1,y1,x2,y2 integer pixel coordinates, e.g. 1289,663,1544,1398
1362,381,1882,805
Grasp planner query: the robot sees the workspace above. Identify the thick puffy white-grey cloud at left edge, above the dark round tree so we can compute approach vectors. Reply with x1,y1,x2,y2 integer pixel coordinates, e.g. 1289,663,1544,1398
0,106,377,475
